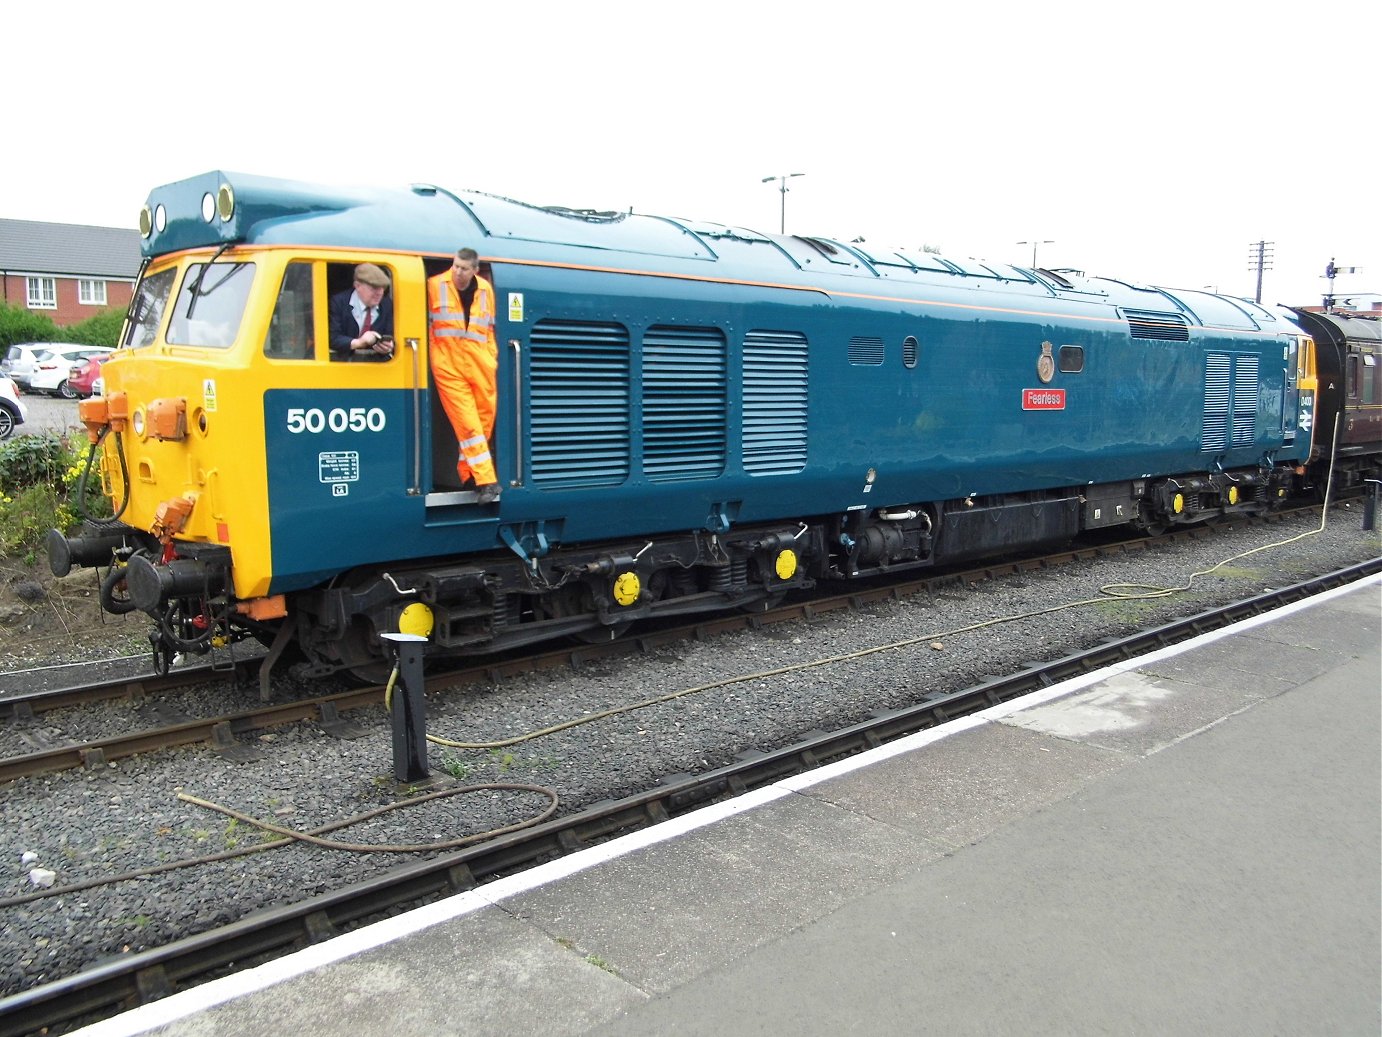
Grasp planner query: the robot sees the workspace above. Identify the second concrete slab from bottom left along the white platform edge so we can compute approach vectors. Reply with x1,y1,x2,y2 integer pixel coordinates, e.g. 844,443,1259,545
506,795,944,991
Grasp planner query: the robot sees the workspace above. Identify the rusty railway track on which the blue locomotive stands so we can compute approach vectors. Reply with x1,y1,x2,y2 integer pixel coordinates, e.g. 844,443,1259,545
0,516,1277,781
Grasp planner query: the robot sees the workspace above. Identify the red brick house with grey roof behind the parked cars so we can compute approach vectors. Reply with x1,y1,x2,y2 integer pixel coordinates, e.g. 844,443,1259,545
0,218,140,326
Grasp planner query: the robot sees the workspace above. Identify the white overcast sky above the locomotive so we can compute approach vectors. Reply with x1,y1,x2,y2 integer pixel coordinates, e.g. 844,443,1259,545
0,0,1382,304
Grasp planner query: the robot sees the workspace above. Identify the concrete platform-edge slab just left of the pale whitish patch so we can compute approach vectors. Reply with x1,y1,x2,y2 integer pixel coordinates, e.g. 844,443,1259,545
808,723,1132,848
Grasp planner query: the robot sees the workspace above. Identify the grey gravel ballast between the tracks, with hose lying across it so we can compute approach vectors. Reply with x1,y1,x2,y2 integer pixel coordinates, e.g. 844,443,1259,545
0,517,1382,994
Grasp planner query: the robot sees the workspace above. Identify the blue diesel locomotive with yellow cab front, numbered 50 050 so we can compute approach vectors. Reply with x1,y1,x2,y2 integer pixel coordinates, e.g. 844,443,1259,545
48,173,1317,678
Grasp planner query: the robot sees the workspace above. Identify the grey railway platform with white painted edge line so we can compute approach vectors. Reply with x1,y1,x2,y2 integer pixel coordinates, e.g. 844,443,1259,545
82,577,1382,1037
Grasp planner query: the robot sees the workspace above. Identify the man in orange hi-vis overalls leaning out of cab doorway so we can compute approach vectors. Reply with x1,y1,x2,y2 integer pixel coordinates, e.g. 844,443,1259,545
427,249,499,505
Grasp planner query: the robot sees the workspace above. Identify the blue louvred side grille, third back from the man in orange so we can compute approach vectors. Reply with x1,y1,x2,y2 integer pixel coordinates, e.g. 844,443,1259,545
744,330,807,476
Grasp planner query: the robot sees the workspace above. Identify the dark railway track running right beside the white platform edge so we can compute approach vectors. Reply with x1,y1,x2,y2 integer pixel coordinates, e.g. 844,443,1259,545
0,559,1382,1037
